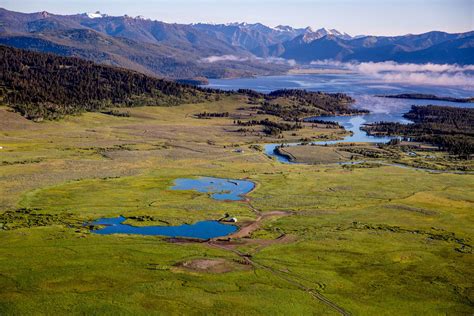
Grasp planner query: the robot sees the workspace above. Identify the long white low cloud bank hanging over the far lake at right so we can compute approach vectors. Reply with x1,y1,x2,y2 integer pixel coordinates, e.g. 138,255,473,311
311,60,474,87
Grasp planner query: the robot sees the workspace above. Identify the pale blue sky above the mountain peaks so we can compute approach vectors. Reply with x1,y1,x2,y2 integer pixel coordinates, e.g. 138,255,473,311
0,0,474,35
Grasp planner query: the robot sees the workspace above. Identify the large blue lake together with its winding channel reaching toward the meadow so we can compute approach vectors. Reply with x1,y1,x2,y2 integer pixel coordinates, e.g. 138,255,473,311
208,73,474,163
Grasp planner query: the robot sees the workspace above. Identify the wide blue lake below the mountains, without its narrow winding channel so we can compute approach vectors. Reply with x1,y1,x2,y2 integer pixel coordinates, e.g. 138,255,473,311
209,73,474,121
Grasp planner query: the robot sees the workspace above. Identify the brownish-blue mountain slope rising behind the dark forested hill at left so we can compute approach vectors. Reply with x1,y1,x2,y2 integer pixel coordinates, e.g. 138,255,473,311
0,8,287,78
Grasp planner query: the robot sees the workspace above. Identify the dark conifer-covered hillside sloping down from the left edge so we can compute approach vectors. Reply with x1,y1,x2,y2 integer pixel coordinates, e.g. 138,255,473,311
0,46,222,120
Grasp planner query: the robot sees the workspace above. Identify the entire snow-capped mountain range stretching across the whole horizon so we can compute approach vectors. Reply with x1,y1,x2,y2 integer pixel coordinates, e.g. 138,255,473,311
0,9,474,78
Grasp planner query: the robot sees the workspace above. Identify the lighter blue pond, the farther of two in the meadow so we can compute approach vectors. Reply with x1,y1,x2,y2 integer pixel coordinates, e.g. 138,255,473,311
172,177,255,201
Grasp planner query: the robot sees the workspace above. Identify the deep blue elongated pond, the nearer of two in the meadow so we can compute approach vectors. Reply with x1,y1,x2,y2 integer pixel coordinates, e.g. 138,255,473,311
91,216,237,239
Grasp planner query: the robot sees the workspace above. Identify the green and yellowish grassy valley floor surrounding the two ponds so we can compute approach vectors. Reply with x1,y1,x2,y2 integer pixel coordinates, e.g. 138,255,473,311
0,99,474,315
